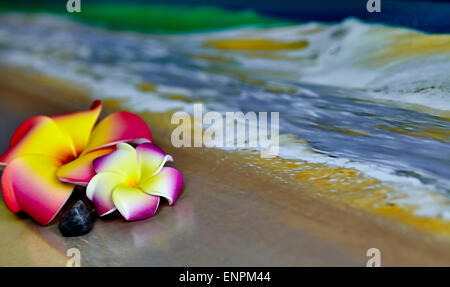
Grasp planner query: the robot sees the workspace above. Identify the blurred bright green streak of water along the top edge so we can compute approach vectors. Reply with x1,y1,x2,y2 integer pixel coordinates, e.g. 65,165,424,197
0,2,286,33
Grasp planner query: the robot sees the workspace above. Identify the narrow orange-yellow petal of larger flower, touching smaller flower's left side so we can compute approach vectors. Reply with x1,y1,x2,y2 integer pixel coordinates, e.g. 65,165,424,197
56,147,116,185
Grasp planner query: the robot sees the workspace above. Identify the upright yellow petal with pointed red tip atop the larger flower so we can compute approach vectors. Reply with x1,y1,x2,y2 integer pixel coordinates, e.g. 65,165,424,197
51,101,102,155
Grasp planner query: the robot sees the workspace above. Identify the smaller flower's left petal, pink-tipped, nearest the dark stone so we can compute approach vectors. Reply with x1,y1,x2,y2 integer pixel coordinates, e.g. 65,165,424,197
86,172,125,216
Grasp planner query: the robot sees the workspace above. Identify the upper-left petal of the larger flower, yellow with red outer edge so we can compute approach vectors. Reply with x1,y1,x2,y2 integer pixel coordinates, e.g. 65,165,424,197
0,116,76,165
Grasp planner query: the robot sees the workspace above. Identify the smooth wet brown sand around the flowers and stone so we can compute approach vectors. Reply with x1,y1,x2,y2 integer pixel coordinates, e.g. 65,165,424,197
0,66,450,266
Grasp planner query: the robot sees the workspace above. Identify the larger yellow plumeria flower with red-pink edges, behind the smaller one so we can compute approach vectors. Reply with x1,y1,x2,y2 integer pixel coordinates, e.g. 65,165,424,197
0,101,152,225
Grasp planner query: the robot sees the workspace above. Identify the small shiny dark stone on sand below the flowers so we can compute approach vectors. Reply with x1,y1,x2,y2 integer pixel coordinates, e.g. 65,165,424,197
58,200,93,237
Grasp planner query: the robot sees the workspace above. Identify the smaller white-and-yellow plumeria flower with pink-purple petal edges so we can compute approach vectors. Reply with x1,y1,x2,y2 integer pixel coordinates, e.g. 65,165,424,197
86,143,183,220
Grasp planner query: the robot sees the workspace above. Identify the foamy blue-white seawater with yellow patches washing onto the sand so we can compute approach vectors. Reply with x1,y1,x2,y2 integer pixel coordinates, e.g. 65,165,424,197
0,14,450,219
